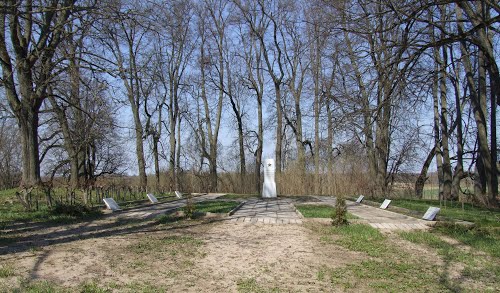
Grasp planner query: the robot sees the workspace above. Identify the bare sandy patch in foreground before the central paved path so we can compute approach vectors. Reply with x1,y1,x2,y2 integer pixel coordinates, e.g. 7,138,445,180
188,222,358,292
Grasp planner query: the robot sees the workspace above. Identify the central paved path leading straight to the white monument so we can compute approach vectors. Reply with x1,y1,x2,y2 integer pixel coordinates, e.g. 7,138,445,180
230,198,302,224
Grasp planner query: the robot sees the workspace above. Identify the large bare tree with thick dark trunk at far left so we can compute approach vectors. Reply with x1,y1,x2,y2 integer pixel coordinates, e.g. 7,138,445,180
0,0,84,187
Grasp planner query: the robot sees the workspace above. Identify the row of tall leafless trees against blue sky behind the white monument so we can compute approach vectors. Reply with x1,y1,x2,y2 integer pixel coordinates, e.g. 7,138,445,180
0,0,500,205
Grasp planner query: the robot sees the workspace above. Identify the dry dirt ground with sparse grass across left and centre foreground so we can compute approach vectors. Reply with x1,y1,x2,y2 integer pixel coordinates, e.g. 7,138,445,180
0,213,368,292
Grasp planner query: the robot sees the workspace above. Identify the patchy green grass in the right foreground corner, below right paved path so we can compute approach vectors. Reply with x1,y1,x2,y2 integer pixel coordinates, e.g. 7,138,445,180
311,220,500,292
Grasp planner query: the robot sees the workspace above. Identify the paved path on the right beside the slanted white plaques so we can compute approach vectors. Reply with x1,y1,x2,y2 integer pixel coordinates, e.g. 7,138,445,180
315,196,432,231
